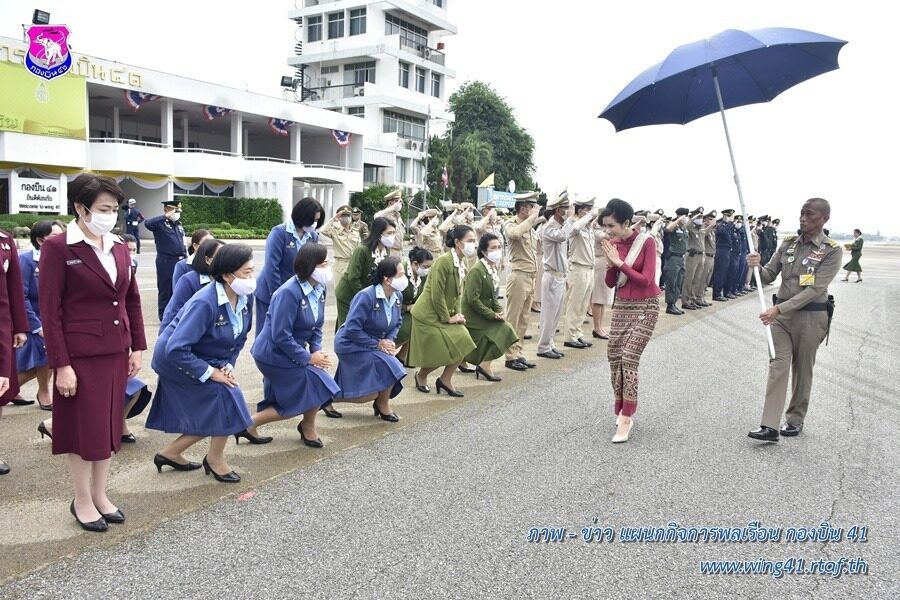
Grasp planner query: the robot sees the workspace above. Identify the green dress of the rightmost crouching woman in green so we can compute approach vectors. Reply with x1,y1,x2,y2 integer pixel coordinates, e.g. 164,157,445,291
462,261,519,365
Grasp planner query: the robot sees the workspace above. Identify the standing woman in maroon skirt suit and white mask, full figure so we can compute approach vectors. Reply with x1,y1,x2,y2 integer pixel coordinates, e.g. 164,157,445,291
38,175,147,531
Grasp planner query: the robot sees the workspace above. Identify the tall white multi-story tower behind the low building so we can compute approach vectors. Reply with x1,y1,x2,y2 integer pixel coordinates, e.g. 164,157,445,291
288,0,457,193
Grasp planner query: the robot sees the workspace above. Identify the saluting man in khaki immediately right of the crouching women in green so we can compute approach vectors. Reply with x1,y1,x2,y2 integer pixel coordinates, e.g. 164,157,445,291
505,192,544,371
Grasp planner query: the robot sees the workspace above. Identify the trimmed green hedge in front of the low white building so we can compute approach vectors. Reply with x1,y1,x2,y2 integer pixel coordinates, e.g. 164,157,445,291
178,196,284,237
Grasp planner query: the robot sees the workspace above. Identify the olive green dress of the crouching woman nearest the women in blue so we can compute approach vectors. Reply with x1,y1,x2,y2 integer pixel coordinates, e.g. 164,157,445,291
406,252,475,369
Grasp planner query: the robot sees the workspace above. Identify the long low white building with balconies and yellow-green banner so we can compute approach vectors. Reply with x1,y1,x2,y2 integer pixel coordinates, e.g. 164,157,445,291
0,37,365,229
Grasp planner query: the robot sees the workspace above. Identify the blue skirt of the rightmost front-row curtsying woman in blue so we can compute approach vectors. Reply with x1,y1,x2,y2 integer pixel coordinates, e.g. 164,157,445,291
334,350,406,398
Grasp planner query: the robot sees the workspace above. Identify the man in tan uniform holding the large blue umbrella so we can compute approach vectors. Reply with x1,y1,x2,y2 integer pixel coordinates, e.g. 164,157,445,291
747,198,841,442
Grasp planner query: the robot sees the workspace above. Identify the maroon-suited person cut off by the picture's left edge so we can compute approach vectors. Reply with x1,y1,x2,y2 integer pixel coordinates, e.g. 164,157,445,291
0,231,28,475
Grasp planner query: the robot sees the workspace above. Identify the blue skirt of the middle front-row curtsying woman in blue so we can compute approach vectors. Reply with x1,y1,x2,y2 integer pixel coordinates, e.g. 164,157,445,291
256,361,341,418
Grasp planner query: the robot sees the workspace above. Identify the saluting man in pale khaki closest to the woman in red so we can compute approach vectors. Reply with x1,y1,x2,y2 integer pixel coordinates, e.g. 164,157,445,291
563,198,595,349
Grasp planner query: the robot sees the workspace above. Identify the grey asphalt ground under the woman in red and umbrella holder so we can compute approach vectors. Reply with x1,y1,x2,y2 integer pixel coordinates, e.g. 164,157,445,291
0,249,900,600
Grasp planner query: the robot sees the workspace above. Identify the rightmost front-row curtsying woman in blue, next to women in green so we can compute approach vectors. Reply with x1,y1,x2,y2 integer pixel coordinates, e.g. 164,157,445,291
334,256,409,422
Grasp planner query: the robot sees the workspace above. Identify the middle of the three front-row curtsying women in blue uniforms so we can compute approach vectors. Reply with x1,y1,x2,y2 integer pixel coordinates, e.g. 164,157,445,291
244,242,340,448
